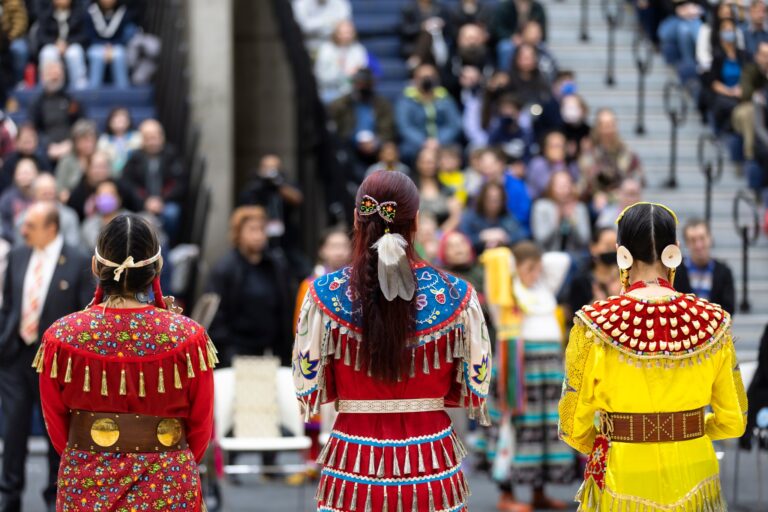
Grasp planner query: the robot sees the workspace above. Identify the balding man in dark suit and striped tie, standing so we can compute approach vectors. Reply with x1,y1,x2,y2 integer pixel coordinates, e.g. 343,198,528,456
0,202,94,512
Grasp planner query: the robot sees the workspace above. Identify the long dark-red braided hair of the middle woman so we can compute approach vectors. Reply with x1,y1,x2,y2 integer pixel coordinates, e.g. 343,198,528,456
350,171,419,382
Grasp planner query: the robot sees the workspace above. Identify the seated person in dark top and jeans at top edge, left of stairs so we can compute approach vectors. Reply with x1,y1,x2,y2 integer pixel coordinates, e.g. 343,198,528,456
493,0,547,59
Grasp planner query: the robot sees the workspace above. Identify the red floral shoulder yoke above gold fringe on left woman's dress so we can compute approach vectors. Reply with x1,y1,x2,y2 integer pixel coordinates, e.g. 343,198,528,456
50,307,200,357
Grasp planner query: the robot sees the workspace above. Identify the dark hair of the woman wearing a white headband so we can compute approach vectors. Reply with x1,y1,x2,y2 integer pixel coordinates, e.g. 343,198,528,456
96,214,163,296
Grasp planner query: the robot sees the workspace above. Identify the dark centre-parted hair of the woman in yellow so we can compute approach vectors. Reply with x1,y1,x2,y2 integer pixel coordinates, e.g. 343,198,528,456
617,203,677,264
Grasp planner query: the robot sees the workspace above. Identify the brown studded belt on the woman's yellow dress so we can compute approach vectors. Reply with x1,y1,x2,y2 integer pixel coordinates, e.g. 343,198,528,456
606,407,704,443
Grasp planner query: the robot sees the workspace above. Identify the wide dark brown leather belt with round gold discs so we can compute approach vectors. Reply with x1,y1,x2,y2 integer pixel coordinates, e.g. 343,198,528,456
67,411,188,453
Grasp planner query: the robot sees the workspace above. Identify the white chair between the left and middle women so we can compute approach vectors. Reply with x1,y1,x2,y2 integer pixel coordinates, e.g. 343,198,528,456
213,368,311,474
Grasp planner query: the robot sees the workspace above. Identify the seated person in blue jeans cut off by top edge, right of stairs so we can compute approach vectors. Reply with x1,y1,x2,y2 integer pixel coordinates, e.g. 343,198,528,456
658,0,704,70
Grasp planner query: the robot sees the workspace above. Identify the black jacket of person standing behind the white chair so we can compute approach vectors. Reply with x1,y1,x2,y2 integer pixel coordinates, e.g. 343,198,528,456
206,249,295,366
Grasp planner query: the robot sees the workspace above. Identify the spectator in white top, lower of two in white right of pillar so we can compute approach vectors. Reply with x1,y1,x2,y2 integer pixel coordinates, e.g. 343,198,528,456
315,20,368,103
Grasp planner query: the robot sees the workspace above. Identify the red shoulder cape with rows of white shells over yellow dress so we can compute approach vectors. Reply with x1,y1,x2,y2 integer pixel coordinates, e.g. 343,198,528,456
576,293,731,361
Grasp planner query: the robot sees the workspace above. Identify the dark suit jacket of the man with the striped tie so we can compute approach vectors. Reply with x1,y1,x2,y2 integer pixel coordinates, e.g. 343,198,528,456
0,244,95,366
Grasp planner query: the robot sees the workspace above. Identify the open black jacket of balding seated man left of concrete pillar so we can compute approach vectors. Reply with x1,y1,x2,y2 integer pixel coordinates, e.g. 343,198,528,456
123,144,187,203
